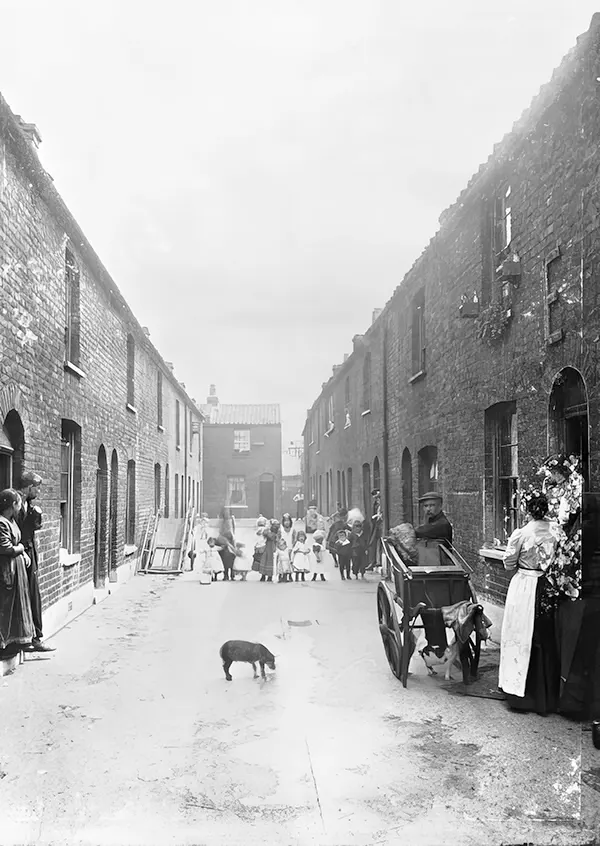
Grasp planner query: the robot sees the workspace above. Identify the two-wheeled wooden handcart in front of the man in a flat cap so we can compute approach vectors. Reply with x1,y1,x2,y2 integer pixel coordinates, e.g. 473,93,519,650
377,538,482,687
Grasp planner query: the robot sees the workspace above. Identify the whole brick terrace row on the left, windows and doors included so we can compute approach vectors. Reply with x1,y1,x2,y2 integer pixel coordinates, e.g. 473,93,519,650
0,91,202,635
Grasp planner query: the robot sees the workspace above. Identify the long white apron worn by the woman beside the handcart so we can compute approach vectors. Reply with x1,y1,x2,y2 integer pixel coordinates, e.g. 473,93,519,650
498,568,543,696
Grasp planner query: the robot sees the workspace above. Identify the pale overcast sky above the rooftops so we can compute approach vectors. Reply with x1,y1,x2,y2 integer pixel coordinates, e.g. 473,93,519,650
0,0,600,440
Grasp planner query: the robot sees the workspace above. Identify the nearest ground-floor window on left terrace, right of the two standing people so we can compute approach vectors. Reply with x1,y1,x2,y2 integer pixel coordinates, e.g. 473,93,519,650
60,420,81,553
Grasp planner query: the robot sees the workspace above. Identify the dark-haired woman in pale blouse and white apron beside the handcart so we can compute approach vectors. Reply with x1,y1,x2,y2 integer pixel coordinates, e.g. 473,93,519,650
498,491,560,716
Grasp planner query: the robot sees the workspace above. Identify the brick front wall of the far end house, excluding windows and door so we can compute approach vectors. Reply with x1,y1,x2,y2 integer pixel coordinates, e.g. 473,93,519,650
203,423,282,518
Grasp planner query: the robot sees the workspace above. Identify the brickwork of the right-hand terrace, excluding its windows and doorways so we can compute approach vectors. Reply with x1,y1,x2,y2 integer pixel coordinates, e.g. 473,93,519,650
305,16,600,601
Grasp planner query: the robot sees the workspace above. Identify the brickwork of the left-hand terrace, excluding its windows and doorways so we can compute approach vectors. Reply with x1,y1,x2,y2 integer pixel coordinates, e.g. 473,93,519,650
0,101,201,607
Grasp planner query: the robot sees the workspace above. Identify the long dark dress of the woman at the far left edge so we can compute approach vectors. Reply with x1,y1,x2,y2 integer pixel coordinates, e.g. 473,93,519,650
0,516,35,649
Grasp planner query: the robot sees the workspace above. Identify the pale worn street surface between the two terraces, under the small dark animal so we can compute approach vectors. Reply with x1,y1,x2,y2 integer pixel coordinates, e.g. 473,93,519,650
0,530,598,846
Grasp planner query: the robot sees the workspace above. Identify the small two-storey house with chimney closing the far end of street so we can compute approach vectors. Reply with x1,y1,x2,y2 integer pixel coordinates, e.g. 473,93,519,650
202,385,281,518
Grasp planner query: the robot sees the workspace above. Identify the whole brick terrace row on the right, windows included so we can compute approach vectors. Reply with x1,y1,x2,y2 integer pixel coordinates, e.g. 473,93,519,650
304,15,600,624
